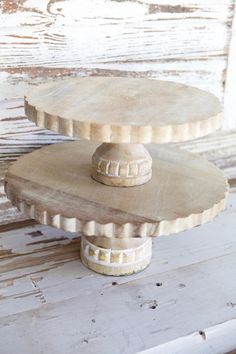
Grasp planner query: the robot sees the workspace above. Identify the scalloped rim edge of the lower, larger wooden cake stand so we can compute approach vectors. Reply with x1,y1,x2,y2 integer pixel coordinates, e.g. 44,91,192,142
5,178,229,238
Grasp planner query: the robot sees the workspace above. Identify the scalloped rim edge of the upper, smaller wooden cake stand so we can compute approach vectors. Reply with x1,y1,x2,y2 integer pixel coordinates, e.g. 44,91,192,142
24,96,223,144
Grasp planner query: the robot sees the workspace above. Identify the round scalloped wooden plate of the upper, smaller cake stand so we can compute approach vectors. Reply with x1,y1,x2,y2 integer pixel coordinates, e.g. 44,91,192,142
25,77,222,144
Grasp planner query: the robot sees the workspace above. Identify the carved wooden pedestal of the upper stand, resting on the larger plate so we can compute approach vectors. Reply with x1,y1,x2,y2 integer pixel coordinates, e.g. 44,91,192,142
92,143,152,187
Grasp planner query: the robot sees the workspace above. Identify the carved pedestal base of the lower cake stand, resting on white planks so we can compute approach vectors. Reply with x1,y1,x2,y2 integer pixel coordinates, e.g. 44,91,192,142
81,236,152,275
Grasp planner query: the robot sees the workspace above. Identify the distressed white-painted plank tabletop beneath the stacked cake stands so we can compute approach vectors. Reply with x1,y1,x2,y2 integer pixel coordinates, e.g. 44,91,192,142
0,193,236,354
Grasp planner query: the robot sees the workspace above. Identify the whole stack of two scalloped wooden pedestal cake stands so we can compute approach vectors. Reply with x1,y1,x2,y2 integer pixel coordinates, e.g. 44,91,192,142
5,77,228,275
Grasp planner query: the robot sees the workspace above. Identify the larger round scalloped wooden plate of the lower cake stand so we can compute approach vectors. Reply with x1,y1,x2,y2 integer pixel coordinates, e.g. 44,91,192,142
5,141,228,237
